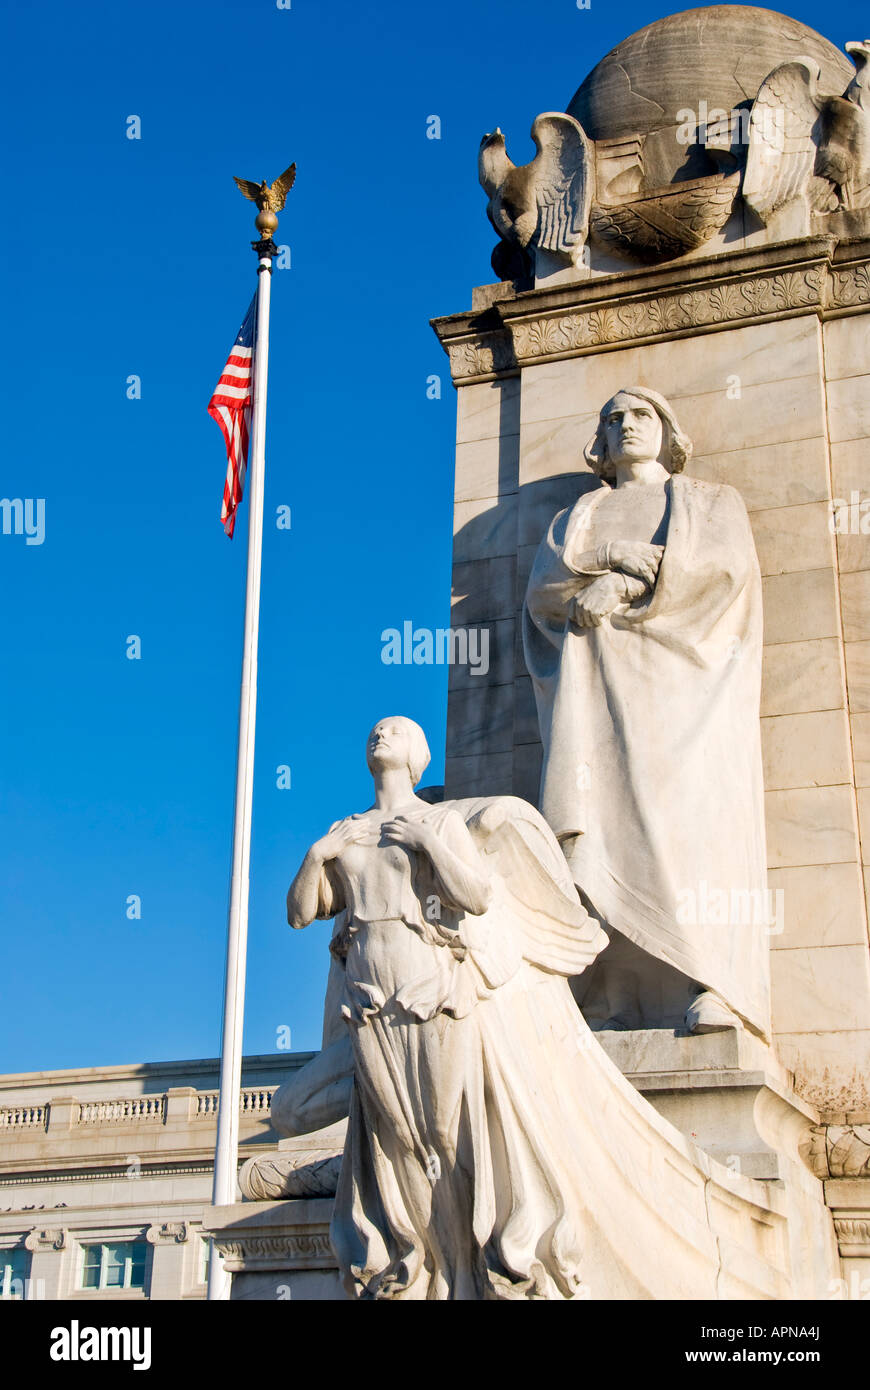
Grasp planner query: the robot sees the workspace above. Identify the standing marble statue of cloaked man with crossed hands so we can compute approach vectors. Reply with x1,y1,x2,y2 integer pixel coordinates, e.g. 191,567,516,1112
524,386,770,1037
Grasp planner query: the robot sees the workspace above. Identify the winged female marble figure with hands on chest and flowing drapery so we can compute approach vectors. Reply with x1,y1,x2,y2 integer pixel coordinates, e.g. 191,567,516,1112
265,716,778,1300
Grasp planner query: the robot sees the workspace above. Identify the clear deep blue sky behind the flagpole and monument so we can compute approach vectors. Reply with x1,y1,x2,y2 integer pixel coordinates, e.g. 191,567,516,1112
0,0,867,1072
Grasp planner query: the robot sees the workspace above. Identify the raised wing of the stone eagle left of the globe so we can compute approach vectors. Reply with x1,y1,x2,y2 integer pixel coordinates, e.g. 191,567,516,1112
531,111,593,256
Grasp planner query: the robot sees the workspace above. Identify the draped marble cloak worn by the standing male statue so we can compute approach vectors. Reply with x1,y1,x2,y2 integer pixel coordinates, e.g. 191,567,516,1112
524,475,770,1036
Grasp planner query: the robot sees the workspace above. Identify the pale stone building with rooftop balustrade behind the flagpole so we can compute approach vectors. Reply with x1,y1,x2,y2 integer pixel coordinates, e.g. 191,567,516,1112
0,1054,304,1300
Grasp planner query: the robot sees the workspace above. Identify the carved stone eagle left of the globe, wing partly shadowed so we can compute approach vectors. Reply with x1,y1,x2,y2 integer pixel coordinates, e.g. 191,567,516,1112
478,111,593,274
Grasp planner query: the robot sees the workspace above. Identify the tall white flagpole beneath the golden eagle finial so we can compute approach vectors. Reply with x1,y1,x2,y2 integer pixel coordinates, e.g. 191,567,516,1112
208,222,271,1300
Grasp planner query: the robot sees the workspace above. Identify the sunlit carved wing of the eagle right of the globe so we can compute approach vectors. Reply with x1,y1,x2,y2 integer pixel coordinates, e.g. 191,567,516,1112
744,58,826,222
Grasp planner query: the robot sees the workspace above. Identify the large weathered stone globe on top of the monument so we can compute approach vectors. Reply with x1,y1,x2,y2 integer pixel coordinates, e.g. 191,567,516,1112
567,4,853,189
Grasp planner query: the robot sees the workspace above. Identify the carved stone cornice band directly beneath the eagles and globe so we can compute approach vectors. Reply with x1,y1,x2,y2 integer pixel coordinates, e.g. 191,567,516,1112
434,239,870,385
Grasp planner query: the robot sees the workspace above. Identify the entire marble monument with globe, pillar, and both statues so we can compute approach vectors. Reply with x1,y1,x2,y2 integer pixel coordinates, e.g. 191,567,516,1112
211,6,870,1300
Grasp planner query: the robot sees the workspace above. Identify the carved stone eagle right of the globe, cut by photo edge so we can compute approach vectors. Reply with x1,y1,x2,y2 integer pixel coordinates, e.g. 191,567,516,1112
742,39,870,224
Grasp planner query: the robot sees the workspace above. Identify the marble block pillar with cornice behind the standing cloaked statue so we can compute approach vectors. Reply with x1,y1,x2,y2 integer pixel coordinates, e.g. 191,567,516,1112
435,238,870,1112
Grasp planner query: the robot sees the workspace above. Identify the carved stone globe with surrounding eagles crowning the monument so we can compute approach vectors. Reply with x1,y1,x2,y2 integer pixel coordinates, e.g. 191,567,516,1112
479,6,870,278
